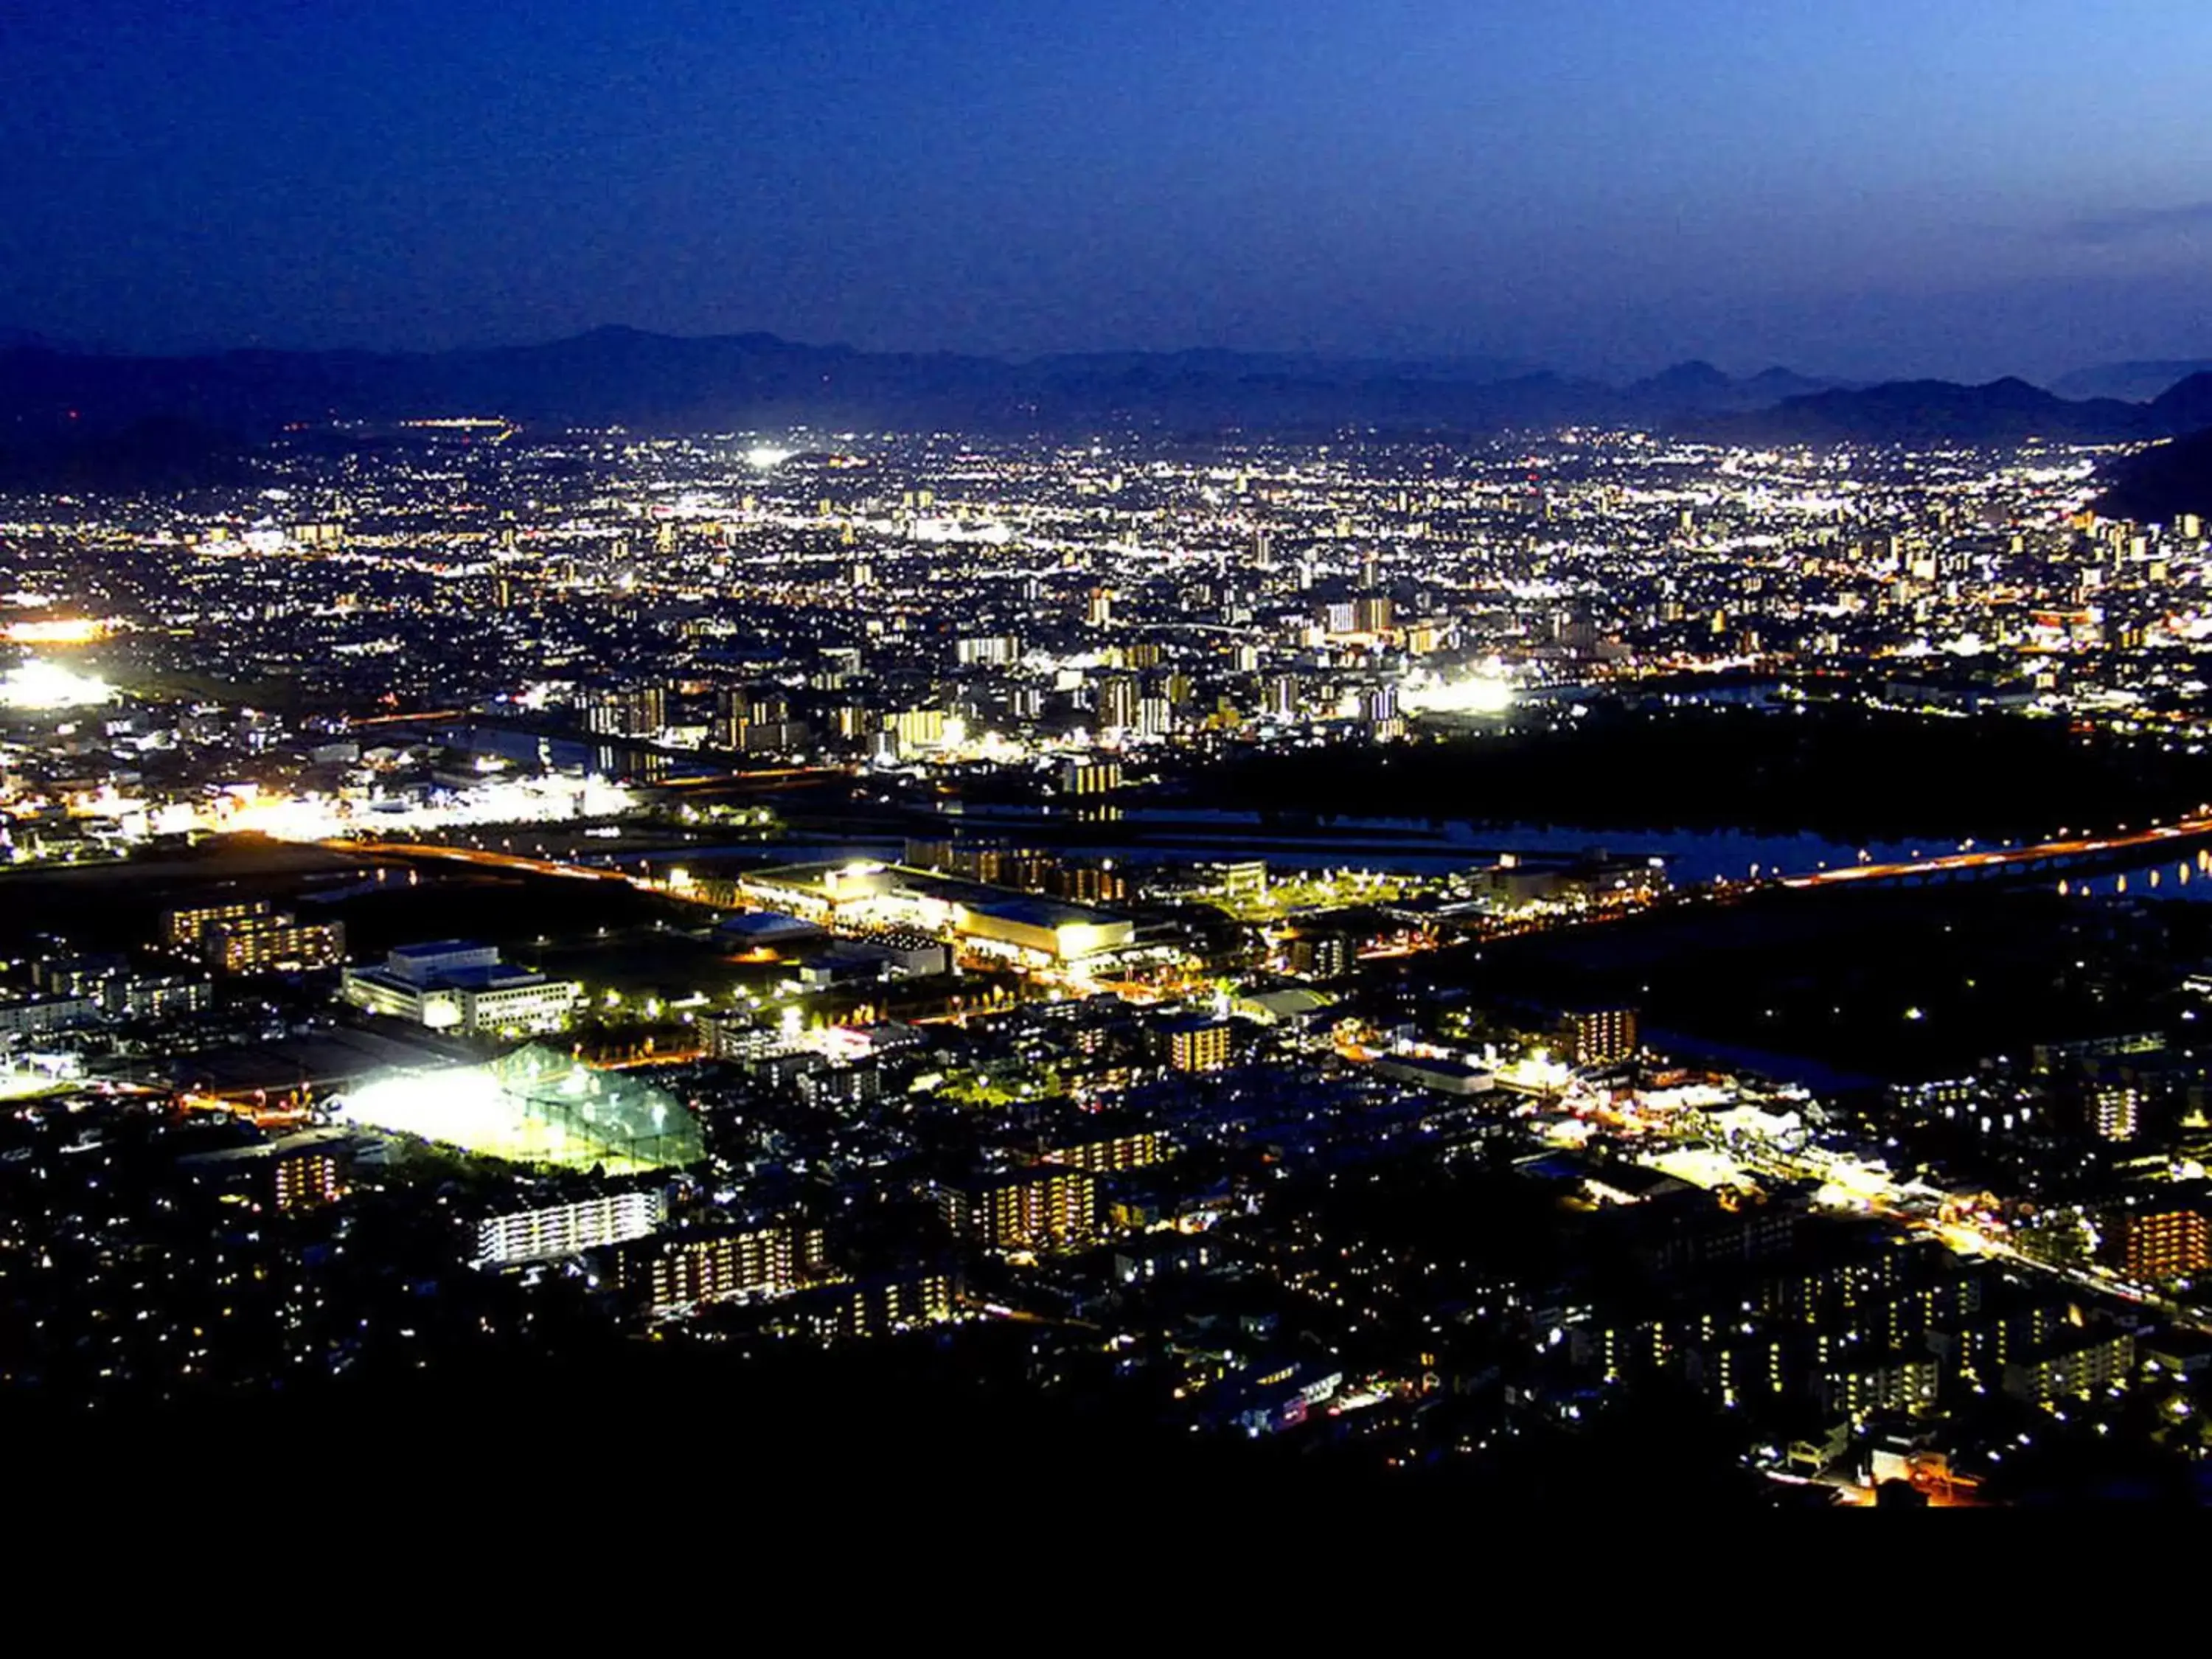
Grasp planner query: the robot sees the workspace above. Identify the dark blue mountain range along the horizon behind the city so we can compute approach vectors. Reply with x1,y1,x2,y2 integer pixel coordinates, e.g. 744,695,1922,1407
0,327,2212,449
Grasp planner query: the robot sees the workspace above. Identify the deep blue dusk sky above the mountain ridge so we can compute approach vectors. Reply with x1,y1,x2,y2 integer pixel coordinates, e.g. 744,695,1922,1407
0,0,2212,376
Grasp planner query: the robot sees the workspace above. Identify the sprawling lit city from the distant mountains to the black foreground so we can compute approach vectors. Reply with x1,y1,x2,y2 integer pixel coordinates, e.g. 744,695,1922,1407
0,411,2212,1509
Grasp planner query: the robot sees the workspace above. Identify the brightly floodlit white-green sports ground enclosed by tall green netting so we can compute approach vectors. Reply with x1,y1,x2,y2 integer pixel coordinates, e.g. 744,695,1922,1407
336,1044,706,1175
